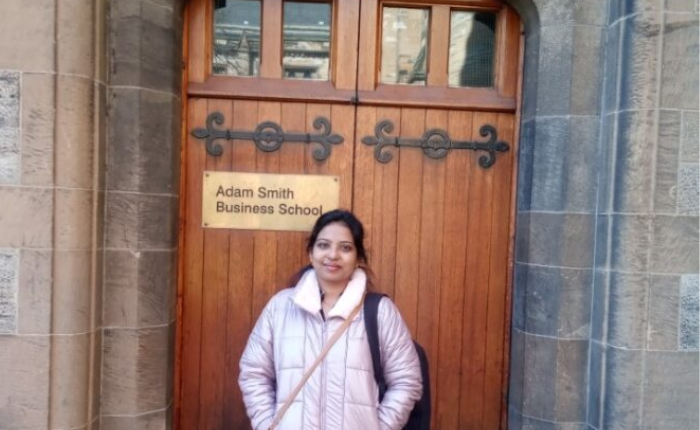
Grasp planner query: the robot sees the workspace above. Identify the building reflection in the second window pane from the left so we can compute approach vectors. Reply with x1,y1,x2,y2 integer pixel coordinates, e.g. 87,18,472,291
282,2,331,81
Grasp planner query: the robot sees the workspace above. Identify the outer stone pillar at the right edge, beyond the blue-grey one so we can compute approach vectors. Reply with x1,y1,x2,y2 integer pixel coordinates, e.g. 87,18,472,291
588,0,700,430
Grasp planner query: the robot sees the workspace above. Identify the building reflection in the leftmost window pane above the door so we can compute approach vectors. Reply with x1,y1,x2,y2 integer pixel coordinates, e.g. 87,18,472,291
212,0,260,76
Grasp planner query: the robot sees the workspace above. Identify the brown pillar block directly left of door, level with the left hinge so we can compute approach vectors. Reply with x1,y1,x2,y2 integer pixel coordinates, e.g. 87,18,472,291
107,88,180,194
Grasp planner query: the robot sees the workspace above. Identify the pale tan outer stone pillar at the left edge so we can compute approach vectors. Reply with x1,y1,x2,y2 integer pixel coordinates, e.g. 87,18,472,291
0,0,105,429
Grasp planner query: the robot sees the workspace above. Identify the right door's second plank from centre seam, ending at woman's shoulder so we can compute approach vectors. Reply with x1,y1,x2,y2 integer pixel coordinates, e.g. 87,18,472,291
394,109,425,336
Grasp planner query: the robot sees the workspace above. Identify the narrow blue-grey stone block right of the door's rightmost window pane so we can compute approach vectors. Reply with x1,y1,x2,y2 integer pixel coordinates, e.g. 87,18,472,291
537,25,574,116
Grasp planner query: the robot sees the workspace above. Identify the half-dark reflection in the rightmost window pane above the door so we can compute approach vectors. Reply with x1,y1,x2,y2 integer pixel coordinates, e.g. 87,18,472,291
449,11,496,87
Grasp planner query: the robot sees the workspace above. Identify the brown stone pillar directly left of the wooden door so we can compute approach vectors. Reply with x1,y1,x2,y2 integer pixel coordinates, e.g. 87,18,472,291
101,0,182,430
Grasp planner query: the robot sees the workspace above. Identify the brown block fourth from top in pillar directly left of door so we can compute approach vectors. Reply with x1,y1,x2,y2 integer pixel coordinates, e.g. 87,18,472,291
104,251,175,327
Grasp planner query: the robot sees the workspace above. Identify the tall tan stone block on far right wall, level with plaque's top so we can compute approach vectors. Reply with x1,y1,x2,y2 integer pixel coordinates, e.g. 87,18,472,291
613,110,657,213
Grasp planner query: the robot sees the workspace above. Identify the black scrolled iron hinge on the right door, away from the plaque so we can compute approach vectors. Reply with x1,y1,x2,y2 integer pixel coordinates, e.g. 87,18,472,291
362,120,510,169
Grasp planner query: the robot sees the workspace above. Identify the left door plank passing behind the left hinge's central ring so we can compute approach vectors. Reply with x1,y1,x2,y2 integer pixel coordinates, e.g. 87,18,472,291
253,102,282,319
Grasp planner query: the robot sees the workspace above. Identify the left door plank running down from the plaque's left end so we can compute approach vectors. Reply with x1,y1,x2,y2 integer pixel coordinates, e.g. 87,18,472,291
193,100,233,430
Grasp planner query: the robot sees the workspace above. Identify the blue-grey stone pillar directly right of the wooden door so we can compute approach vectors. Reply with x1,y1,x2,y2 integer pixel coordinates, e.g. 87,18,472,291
508,0,607,430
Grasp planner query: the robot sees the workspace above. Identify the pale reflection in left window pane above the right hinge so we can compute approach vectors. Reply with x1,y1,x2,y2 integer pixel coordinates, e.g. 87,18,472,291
380,7,430,85
